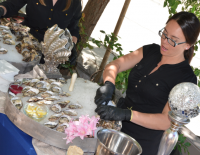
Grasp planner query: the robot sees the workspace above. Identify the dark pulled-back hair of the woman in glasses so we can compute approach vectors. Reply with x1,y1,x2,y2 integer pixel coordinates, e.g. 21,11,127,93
166,11,200,63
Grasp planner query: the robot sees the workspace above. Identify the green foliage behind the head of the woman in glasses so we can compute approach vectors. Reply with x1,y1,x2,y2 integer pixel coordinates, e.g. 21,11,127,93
163,0,200,87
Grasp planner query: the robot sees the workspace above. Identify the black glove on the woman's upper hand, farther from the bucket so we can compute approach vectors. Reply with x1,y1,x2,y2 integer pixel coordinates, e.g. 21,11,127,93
94,81,115,106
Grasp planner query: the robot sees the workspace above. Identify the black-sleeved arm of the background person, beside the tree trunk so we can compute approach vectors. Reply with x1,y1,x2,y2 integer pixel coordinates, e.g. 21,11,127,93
67,0,82,40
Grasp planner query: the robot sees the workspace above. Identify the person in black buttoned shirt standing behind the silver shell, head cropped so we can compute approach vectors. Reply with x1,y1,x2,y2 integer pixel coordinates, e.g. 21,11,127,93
0,0,82,64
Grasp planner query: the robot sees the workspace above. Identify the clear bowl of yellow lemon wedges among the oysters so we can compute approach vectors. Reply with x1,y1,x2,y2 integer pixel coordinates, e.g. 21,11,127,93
23,103,48,121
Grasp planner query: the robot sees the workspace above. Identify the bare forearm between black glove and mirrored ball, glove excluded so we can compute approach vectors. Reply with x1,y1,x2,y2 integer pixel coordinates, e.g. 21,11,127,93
130,102,171,130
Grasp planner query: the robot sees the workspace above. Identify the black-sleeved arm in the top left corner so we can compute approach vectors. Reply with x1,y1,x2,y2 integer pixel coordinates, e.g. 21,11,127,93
0,0,27,17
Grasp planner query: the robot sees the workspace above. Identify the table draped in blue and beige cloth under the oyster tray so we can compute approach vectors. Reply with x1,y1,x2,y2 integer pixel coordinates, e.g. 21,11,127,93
0,72,94,155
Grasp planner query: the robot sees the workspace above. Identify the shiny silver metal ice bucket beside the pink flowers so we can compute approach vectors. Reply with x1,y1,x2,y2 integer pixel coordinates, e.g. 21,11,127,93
95,129,142,155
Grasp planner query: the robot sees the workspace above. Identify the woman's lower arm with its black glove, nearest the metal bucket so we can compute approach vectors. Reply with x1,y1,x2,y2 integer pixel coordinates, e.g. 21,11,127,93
95,102,170,130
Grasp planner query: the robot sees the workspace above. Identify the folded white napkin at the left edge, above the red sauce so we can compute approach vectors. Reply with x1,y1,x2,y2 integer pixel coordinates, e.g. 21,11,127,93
0,60,19,92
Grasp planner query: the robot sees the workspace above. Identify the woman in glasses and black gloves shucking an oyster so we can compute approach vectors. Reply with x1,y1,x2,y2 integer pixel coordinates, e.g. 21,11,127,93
95,12,200,155
